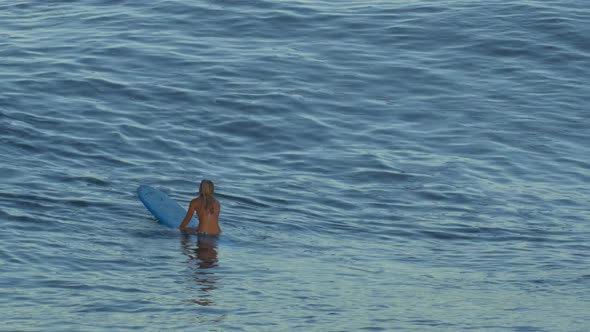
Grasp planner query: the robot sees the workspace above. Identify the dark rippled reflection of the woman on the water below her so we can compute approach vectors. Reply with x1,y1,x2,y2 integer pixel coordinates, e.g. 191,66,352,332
181,234,218,306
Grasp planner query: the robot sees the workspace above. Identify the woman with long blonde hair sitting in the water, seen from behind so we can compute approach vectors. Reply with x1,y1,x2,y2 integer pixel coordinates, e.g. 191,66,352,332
179,180,221,235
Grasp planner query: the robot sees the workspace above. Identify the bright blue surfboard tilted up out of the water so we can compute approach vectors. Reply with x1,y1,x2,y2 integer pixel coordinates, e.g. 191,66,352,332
137,185,198,228
